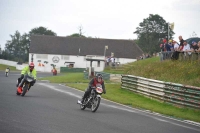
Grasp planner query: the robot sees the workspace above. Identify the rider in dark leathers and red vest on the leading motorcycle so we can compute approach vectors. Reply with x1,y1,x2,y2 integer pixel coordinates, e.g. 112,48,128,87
81,74,106,104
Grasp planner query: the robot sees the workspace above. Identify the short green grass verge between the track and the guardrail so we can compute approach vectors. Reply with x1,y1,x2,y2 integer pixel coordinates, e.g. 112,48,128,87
39,73,200,122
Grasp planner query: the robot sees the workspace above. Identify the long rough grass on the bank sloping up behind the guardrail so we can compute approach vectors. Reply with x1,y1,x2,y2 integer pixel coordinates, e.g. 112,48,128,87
124,57,200,87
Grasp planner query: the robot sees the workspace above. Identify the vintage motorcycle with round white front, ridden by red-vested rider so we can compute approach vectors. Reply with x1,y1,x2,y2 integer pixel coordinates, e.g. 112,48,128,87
77,84,103,112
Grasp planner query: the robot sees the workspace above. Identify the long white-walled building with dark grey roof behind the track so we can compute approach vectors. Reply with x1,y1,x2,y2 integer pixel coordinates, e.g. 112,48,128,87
29,35,143,72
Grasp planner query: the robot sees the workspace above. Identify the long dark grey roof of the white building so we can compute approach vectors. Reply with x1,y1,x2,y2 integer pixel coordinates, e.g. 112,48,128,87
29,35,143,59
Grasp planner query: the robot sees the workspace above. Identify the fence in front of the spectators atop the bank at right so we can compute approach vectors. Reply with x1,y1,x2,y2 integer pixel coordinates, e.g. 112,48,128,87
159,51,200,63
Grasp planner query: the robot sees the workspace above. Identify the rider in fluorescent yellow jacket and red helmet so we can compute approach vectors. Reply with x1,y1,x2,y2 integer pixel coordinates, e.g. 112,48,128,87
17,62,37,93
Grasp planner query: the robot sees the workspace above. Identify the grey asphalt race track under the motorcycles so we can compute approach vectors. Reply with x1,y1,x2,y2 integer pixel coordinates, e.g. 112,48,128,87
0,71,200,133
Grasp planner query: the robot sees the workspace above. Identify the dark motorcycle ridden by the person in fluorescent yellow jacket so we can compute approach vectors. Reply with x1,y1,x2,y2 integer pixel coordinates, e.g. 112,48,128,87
16,74,34,96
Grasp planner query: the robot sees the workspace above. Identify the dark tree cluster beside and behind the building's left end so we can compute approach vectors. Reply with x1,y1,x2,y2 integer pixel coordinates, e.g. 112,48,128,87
1,27,56,62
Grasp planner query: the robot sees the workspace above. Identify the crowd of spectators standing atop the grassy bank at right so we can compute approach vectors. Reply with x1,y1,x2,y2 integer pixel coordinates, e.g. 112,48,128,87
160,36,200,60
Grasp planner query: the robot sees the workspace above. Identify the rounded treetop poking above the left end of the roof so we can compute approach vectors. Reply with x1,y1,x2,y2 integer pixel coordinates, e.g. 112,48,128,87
29,26,57,36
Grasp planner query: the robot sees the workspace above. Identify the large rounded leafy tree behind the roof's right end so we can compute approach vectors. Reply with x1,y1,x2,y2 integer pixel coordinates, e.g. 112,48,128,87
134,14,174,53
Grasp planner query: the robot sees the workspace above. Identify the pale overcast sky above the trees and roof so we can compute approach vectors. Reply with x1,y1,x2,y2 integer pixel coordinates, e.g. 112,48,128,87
0,0,200,49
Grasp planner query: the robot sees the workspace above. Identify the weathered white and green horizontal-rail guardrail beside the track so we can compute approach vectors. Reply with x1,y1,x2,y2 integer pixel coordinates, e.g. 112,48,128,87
121,75,200,109
